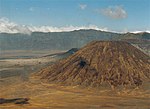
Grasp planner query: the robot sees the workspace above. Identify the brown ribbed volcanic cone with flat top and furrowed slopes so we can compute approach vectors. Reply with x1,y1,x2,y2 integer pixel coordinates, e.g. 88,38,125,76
36,41,150,88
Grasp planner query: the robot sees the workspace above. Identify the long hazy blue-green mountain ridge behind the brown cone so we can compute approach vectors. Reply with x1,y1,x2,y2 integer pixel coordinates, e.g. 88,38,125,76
0,30,150,50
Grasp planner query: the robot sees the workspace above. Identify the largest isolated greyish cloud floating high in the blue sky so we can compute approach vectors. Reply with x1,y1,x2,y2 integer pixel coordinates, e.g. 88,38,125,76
96,6,127,19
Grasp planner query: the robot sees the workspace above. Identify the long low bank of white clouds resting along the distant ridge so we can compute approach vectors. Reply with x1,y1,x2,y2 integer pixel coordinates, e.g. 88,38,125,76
0,18,108,34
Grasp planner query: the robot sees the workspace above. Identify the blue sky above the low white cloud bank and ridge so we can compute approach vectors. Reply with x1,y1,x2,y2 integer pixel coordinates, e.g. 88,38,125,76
0,0,150,32
